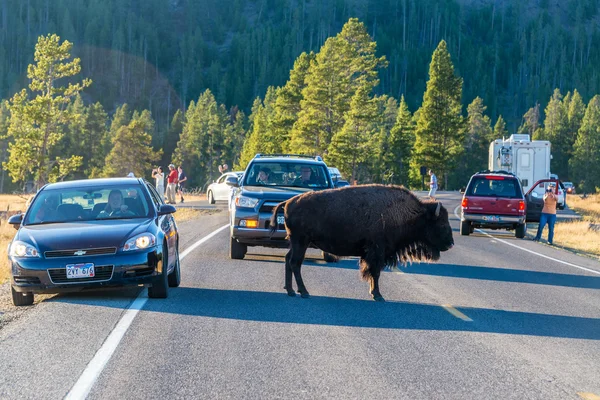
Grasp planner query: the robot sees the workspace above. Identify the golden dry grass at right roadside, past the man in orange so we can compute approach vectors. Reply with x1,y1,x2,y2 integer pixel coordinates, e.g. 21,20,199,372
543,194,600,256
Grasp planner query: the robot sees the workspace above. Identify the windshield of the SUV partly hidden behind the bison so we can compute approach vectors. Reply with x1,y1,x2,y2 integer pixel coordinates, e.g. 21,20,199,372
244,162,330,188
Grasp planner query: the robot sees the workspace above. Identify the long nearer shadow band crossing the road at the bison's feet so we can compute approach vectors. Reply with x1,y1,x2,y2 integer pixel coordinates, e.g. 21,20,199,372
134,287,600,340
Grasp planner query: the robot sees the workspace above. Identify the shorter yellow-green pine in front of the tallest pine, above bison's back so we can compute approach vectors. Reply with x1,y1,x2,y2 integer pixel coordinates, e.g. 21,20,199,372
326,85,377,181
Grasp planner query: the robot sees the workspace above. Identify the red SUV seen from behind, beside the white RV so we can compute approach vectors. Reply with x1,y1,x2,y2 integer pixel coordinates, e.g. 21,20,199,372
460,171,526,239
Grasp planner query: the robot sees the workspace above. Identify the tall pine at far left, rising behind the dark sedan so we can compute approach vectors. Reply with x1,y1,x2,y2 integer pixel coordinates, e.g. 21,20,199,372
3,35,91,187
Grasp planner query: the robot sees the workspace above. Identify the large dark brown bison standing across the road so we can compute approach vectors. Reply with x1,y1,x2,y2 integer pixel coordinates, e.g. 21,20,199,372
270,185,454,301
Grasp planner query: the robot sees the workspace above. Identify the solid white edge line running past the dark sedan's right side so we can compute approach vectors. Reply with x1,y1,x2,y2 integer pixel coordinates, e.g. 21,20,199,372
65,224,229,400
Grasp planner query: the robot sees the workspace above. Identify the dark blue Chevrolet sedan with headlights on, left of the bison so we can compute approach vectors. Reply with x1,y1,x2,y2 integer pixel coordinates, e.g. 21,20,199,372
9,178,181,306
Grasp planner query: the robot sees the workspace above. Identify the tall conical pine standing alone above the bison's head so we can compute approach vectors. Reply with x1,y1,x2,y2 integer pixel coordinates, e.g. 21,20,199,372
411,40,464,186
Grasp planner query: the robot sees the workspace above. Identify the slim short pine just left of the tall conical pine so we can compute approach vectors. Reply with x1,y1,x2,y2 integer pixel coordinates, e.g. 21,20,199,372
385,96,415,186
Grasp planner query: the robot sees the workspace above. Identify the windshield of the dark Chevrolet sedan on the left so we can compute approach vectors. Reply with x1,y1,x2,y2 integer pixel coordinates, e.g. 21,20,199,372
25,185,150,225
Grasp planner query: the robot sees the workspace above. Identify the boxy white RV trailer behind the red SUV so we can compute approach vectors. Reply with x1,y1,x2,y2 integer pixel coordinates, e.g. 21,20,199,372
488,135,552,192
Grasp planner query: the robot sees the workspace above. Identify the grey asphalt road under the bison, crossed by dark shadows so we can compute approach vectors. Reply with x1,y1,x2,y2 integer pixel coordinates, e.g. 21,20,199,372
0,193,600,399
